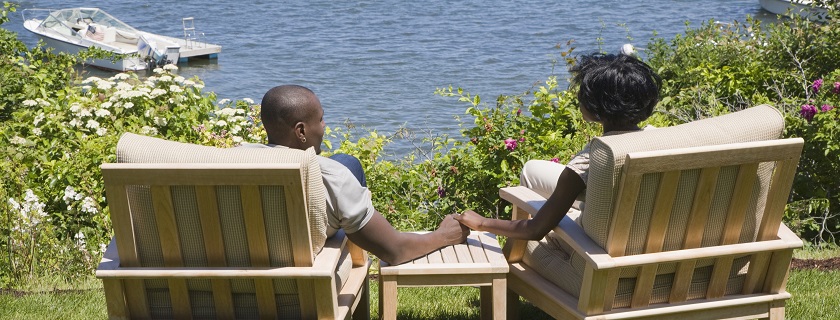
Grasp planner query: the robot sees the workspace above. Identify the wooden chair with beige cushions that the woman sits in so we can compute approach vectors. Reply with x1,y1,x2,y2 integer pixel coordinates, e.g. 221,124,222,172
500,106,803,319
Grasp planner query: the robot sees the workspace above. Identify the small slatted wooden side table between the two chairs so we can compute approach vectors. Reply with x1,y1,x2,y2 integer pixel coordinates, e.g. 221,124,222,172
379,231,508,319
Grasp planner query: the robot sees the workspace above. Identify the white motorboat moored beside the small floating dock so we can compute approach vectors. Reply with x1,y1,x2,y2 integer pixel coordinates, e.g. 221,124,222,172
23,8,181,71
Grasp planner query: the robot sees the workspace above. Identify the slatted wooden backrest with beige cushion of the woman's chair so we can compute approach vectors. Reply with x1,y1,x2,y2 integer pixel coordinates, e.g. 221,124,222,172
581,105,802,256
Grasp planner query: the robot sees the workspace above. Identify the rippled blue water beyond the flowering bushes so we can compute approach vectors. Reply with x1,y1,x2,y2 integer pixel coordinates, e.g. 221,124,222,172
3,0,775,154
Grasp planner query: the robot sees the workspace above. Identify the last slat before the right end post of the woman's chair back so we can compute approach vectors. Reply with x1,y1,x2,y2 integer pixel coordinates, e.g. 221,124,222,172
720,163,758,245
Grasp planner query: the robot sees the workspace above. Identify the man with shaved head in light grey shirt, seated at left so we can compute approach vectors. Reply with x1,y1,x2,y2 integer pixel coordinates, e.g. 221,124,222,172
253,85,469,264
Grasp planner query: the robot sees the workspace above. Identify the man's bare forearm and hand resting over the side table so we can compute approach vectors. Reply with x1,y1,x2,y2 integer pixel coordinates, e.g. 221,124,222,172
347,211,469,265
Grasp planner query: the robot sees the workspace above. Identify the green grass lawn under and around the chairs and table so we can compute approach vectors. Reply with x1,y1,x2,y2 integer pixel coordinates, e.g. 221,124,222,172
0,250,840,319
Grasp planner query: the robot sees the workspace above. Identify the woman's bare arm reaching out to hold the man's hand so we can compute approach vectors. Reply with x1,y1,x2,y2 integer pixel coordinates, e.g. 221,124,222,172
455,168,586,240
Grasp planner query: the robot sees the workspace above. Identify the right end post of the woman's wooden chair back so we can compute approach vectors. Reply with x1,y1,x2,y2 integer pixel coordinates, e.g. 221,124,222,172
757,158,801,241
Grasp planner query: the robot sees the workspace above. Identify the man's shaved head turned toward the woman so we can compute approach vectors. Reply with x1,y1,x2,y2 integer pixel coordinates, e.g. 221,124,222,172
260,85,325,153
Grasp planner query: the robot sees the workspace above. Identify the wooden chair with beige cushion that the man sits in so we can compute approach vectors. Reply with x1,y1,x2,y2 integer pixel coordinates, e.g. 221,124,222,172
96,134,370,319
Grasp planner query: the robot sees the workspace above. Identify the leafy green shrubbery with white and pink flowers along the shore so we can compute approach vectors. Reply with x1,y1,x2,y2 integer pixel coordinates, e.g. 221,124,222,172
0,0,840,288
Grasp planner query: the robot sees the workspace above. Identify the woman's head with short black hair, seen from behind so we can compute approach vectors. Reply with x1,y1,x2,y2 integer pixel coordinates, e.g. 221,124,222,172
570,53,662,128
